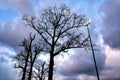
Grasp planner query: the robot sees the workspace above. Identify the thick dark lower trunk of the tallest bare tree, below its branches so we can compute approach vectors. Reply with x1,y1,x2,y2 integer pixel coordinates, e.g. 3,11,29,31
48,54,54,80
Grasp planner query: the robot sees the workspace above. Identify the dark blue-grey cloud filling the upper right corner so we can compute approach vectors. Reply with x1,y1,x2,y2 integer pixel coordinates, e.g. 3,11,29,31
100,0,120,49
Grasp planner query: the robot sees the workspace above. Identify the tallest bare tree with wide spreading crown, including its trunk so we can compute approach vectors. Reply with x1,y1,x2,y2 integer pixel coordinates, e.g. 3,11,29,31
23,5,89,80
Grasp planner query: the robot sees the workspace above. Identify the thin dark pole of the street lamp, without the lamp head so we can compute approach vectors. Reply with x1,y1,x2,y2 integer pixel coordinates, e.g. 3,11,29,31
87,25,100,80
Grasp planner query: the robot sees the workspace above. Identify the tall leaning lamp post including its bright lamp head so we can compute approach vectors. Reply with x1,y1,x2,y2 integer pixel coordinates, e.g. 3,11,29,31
83,19,100,80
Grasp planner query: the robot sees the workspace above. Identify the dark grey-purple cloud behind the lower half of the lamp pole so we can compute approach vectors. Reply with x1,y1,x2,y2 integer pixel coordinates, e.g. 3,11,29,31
58,49,106,76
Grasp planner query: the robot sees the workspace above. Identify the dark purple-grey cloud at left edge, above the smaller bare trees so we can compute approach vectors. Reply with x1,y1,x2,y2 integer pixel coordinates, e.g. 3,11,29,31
0,19,32,49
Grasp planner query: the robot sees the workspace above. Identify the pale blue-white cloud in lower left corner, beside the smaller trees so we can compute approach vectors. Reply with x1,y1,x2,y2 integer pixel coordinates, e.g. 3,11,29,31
0,45,18,80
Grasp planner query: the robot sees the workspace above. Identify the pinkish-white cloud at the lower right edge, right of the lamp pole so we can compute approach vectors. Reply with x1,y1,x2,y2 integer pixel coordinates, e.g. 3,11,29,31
101,45,120,80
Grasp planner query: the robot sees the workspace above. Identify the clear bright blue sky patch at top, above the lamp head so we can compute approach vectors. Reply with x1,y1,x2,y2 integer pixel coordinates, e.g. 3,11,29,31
79,0,103,17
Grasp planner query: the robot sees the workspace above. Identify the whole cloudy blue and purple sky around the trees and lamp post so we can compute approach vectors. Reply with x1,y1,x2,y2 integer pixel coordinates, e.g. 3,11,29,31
0,0,120,80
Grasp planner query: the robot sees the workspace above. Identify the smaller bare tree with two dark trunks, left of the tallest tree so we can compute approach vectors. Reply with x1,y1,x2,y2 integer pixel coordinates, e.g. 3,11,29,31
14,34,43,80
